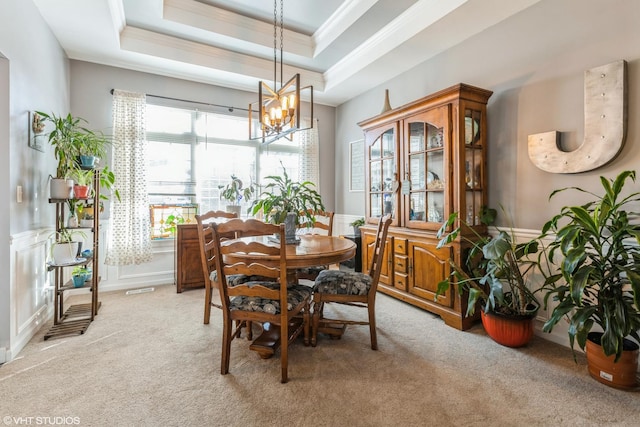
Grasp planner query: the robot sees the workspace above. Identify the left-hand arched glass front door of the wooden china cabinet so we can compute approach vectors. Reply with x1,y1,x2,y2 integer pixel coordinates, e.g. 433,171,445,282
367,125,399,225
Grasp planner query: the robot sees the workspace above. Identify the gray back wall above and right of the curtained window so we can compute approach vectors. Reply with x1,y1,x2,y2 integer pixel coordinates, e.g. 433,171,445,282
70,60,336,209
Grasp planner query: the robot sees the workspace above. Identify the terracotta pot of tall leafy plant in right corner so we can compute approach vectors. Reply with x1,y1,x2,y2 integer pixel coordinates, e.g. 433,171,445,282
586,332,638,389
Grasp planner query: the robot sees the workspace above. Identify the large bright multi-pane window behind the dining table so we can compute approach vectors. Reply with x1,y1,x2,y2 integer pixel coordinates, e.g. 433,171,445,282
146,104,301,239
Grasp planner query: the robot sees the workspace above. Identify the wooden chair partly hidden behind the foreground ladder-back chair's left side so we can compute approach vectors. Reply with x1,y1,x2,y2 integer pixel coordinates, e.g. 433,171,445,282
196,211,239,325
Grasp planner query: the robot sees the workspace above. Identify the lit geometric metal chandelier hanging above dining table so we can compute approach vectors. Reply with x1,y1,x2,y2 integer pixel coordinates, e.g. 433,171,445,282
249,0,313,144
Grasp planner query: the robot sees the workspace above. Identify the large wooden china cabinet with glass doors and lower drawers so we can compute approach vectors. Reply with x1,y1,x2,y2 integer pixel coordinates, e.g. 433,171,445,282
358,84,492,329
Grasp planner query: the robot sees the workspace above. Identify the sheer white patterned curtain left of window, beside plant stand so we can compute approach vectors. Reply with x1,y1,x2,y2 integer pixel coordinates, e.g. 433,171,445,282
105,90,152,265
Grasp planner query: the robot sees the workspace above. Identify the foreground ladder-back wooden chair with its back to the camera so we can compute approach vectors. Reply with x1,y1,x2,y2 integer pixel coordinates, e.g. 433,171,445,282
212,219,311,383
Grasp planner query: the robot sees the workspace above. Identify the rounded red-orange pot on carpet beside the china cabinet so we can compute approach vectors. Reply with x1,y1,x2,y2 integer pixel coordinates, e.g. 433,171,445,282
480,310,537,347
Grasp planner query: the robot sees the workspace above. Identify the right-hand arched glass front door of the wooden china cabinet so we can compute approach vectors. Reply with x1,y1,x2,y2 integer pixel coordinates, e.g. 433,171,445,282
402,107,449,229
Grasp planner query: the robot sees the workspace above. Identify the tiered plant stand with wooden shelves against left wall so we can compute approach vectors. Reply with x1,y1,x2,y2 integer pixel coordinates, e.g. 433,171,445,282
44,170,100,340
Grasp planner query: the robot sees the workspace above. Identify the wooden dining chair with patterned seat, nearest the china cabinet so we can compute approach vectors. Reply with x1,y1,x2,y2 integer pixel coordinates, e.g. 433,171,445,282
311,215,391,350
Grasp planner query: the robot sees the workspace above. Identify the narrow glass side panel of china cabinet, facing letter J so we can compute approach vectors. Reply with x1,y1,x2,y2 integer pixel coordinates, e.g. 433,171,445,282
461,108,485,225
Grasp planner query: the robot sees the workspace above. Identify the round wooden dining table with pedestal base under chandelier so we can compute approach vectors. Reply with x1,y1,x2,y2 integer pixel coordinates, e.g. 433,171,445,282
222,234,357,359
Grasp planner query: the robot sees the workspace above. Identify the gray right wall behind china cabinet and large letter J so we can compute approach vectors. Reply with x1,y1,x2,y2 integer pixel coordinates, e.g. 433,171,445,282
336,0,640,229
